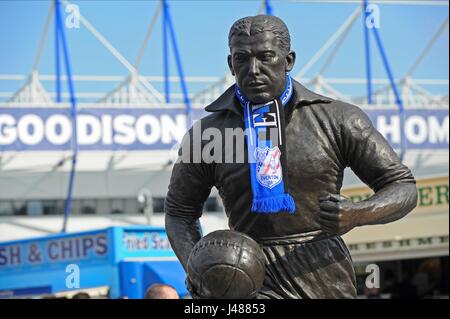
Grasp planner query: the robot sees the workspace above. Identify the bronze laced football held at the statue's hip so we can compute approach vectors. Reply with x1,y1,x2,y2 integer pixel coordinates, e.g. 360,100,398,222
187,230,265,299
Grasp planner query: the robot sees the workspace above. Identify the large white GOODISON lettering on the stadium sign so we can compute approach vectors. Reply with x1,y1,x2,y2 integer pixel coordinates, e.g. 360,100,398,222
0,111,186,151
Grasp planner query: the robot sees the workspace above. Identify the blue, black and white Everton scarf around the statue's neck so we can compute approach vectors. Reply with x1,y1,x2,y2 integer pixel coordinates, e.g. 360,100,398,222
235,75,295,213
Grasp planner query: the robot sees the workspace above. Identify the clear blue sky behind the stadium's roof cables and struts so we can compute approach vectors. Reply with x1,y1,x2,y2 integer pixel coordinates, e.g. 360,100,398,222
0,0,449,97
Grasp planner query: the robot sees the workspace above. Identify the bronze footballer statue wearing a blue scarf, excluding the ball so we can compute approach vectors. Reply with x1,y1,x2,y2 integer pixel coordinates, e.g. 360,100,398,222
165,15,417,298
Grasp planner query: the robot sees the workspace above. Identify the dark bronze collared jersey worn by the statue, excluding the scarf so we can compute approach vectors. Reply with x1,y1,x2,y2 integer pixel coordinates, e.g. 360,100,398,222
165,81,415,242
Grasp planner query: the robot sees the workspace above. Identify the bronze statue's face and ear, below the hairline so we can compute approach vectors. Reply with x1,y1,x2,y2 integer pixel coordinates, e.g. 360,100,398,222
228,31,295,103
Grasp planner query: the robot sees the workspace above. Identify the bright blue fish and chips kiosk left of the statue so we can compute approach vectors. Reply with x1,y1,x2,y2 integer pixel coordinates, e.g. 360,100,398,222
0,226,187,298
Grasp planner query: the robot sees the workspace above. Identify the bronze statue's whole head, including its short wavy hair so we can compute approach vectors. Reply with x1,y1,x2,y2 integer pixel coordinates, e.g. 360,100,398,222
228,15,295,103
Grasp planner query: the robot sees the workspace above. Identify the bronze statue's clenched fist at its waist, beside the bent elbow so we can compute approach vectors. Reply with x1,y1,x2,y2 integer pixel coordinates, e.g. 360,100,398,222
319,194,360,235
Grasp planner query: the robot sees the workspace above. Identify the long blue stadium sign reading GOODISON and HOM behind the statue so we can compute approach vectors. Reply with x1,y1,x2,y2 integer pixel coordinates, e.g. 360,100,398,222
0,108,449,152
